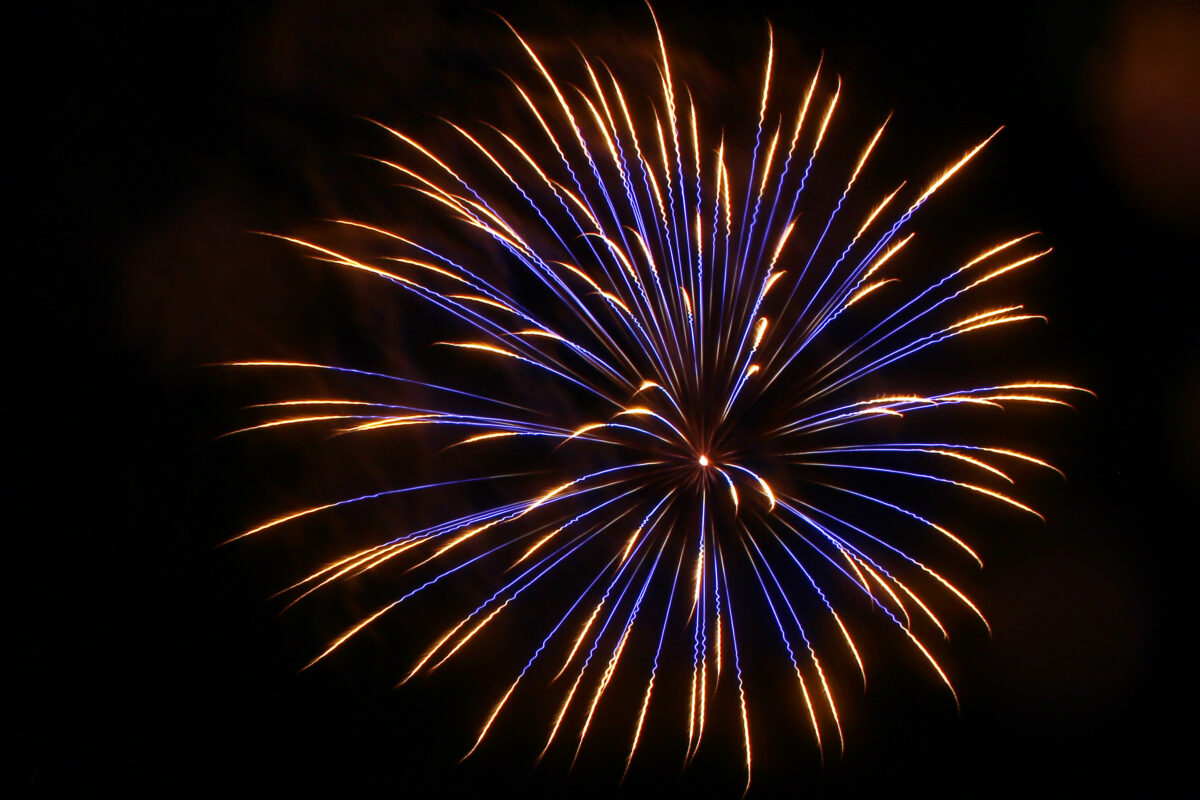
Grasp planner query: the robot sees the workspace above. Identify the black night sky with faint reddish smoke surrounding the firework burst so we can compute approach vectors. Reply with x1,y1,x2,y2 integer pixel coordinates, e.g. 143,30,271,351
16,0,1200,796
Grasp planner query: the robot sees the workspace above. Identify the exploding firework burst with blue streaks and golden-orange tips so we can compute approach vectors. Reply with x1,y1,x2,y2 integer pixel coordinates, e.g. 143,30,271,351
225,7,1080,796
